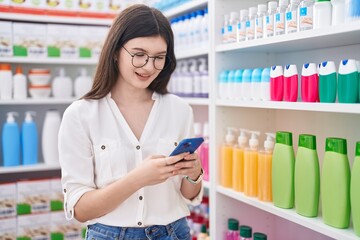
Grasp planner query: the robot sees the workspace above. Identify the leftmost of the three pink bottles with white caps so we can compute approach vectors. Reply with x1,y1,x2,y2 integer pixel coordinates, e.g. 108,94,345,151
270,66,284,101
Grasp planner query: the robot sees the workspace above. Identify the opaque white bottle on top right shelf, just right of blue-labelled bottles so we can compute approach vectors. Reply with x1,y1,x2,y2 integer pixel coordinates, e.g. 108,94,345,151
313,0,332,29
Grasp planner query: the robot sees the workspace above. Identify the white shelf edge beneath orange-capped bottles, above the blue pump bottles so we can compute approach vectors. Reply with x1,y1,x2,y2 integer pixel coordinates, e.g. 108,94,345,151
0,98,75,105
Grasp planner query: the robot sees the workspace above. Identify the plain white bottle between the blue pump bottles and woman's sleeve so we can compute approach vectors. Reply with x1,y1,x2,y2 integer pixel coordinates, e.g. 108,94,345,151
41,109,61,165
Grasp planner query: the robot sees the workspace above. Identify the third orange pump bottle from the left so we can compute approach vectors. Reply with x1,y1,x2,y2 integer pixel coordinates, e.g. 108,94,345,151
244,131,260,197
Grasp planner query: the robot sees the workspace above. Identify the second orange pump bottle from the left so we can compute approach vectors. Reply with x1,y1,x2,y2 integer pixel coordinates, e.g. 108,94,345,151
232,128,249,192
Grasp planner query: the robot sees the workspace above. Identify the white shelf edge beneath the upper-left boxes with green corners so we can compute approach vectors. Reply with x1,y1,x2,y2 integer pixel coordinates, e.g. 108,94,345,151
0,57,98,65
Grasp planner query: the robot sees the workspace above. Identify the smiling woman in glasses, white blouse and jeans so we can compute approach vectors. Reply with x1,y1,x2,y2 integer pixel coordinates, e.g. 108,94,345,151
59,5,202,240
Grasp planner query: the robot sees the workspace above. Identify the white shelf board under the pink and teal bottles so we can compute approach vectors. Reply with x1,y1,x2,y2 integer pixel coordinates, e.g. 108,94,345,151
216,99,360,114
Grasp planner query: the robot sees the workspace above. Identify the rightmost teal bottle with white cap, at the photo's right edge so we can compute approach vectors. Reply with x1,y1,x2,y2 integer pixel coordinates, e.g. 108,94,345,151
338,59,359,103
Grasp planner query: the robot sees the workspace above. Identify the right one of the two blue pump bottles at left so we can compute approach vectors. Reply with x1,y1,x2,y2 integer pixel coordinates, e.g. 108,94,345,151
21,111,39,165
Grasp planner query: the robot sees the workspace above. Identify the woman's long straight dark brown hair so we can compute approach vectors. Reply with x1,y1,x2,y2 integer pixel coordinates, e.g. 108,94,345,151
83,4,176,99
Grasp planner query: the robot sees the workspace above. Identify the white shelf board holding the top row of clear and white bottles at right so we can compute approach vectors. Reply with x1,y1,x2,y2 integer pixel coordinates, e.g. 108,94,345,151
215,21,360,53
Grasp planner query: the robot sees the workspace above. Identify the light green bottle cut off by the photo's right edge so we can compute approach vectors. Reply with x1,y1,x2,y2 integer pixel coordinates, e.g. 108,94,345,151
350,142,360,237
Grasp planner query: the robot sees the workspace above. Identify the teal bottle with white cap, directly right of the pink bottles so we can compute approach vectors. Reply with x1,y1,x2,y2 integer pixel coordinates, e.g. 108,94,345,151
319,61,337,103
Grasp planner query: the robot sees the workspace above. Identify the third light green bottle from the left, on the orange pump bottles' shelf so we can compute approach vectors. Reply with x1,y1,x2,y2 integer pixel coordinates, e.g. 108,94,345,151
321,138,350,228
